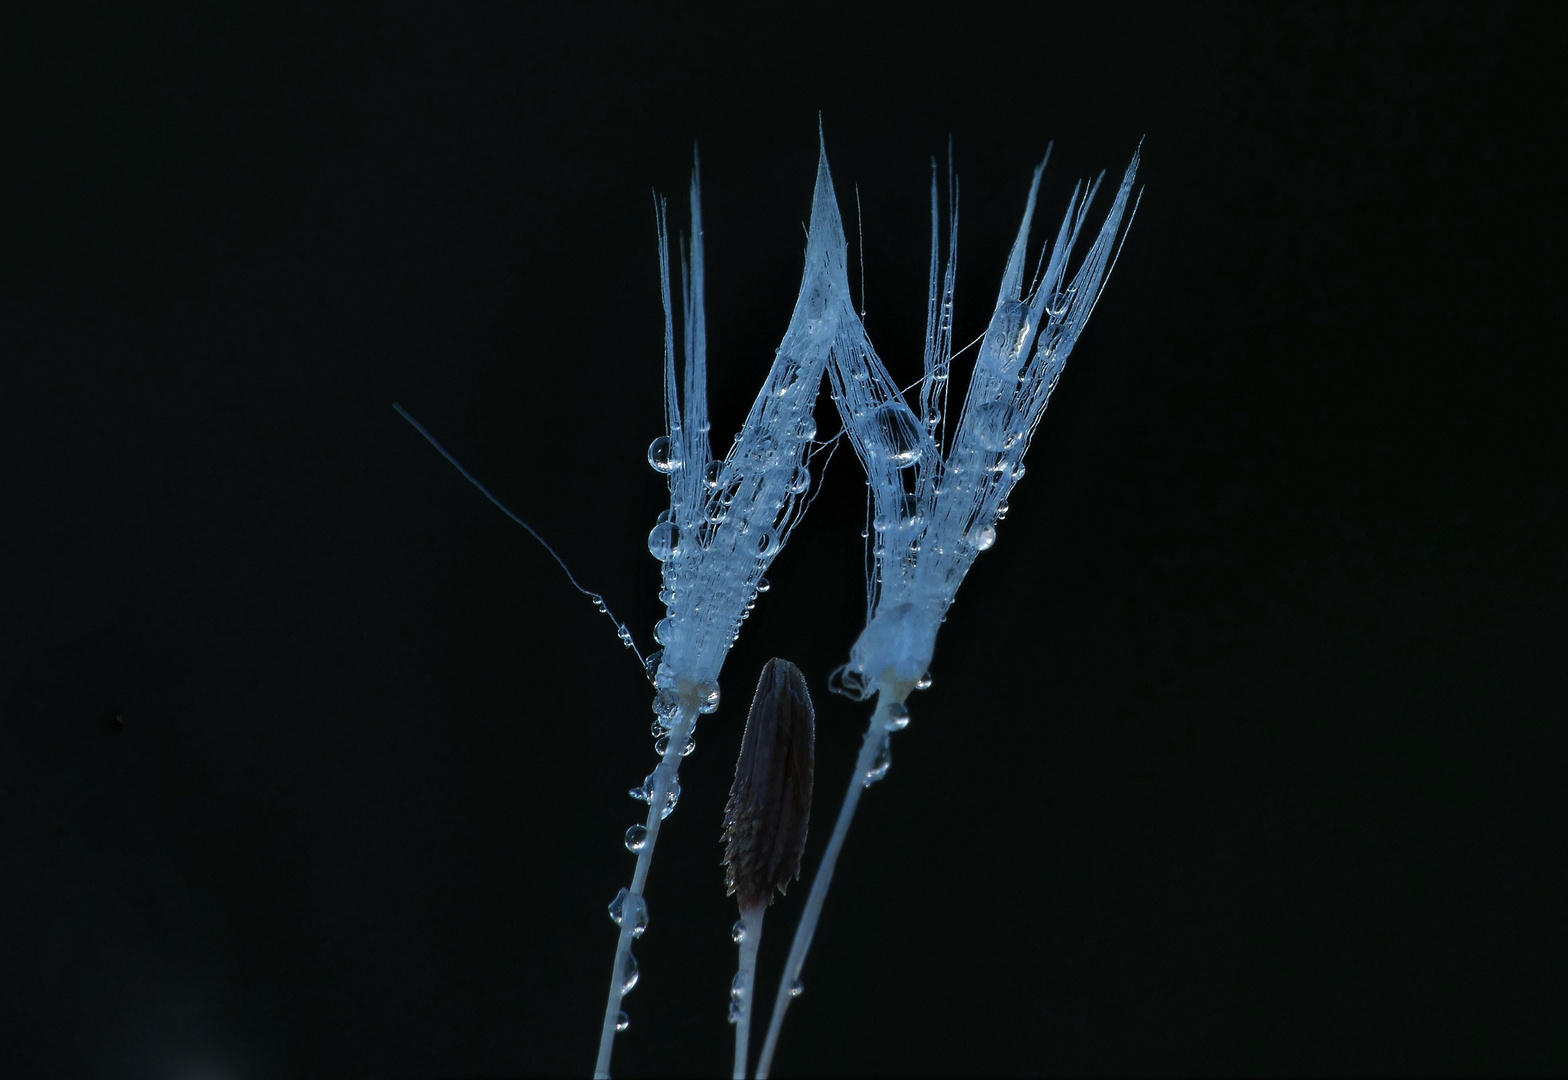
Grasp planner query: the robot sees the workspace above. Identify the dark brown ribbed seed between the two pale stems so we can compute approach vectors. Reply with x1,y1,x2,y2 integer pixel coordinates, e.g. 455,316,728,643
721,658,817,912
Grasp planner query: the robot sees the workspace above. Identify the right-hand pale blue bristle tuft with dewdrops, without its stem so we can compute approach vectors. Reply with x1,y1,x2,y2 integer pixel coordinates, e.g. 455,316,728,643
829,143,1138,698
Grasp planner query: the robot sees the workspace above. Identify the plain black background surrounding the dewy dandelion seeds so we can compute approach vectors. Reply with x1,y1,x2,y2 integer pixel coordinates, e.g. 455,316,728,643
0,5,1568,1078
